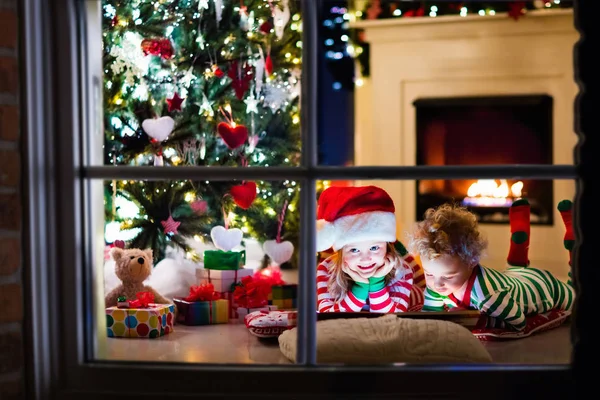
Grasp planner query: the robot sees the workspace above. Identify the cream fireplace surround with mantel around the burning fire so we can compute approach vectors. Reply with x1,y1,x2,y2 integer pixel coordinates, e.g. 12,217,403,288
353,10,579,278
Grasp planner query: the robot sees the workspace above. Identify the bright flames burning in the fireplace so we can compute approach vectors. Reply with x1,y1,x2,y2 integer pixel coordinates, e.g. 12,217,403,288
463,179,523,207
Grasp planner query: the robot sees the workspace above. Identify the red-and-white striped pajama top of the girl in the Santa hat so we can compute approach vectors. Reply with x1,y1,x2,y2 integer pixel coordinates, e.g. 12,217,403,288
317,254,424,313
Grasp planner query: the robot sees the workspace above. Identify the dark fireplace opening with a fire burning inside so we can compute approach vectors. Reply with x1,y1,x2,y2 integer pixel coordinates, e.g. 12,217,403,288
413,95,554,225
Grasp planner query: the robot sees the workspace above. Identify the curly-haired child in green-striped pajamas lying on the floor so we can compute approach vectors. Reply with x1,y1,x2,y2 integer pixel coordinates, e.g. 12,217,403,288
409,199,575,331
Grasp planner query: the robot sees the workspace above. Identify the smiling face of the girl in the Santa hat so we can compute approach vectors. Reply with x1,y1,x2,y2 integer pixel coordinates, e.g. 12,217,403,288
342,241,387,278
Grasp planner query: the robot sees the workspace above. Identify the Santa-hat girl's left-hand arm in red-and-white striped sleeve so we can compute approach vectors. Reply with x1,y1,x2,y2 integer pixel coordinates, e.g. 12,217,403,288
317,263,368,312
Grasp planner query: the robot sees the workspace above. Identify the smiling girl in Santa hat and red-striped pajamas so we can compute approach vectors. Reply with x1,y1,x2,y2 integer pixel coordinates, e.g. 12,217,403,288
317,186,424,313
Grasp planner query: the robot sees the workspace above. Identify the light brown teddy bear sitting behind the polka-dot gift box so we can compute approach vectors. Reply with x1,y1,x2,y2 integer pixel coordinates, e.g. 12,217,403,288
104,247,173,307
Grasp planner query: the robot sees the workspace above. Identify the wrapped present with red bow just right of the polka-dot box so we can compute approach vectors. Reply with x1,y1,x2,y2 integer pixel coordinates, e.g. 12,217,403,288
173,283,230,325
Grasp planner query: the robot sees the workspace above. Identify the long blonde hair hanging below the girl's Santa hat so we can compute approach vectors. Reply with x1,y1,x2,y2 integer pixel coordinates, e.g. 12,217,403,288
327,242,407,301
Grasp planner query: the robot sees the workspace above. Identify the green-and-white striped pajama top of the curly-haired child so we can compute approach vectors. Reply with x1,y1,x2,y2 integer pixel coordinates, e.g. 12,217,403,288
423,265,575,330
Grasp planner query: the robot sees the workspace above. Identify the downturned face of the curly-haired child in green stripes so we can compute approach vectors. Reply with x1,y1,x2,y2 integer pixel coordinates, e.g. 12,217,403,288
421,257,472,296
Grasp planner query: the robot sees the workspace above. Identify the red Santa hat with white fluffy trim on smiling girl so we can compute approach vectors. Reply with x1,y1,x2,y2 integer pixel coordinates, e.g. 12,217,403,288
317,186,396,251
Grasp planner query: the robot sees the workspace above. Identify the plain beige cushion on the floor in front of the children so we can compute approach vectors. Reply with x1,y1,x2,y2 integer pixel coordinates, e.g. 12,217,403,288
278,314,492,364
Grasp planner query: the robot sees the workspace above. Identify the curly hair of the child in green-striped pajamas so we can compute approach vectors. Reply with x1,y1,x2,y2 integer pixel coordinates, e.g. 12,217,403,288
408,203,488,266
